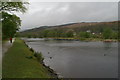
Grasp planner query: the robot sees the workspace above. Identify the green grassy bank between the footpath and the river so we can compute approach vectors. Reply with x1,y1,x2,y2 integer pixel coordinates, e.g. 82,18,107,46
2,39,54,78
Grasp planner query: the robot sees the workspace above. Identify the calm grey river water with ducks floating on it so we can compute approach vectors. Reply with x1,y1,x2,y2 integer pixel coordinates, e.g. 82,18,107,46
23,39,118,78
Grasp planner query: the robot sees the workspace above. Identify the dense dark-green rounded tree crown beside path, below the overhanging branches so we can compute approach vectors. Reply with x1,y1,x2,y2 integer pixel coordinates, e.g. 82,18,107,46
2,12,21,39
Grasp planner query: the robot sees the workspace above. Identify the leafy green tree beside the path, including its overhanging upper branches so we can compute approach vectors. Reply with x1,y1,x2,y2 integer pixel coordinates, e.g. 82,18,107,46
0,1,28,39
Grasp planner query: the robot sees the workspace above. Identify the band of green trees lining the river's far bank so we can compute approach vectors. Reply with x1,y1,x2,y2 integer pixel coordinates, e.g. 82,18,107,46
21,27,118,39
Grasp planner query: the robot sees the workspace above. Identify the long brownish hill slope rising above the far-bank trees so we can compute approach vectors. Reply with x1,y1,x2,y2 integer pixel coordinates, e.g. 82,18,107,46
20,21,118,36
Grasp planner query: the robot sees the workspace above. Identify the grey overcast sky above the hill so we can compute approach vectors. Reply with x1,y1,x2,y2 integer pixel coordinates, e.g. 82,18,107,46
18,2,118,30
